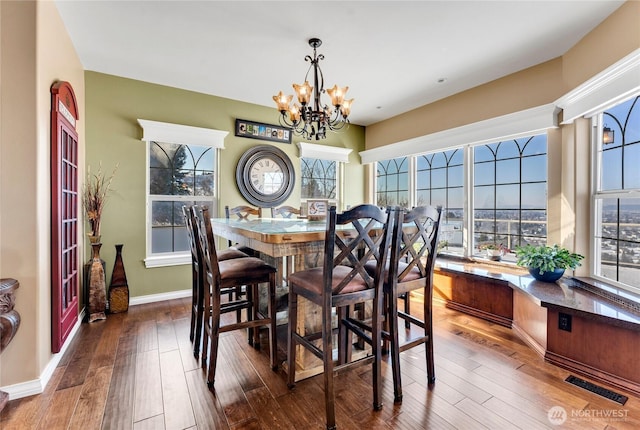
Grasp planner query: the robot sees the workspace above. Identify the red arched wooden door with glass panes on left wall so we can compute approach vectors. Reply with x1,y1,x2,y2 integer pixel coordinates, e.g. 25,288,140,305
51,82,80,352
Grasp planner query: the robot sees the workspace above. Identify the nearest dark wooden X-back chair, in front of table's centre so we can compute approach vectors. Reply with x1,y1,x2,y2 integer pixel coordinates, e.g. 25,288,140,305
287,205,396,429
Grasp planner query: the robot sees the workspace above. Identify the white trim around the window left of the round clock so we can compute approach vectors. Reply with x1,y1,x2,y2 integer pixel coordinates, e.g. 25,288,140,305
138,119,229,268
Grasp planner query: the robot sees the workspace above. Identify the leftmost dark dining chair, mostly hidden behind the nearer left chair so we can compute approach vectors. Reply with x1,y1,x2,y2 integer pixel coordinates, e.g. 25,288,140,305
182,206,248,358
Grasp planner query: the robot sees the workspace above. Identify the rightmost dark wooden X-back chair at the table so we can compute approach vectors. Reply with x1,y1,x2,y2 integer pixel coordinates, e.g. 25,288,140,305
384,206,442,403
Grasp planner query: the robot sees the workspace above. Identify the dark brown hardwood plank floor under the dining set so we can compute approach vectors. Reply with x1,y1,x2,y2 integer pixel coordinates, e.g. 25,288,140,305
0,299,640,430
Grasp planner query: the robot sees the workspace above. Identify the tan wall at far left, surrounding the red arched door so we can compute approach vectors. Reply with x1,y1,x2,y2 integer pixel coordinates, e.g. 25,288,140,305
0,2,84,386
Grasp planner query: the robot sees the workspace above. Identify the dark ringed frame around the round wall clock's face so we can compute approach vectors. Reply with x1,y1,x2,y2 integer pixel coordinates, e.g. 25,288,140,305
236,145,295,208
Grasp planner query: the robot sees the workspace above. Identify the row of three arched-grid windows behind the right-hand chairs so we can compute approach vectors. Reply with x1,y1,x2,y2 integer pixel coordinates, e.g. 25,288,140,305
376,134,547,262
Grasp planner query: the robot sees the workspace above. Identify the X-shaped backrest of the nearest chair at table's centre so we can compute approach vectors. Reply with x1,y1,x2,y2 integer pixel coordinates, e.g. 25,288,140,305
323,204,397,294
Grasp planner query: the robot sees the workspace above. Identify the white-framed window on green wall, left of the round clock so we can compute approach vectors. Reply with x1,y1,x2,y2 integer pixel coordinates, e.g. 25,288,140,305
138,120,227,267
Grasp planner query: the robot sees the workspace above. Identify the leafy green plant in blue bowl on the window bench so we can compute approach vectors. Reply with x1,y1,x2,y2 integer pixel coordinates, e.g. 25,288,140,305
516,245,584,282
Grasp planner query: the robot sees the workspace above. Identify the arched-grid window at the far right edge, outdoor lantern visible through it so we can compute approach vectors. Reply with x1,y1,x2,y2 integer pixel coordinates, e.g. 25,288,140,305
593,96,640,292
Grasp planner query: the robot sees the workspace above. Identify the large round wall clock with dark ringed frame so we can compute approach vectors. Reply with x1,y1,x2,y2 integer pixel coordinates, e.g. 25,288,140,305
236,145,295,207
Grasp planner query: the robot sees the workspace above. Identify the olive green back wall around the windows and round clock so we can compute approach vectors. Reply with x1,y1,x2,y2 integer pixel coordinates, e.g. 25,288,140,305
85,72,365,297
